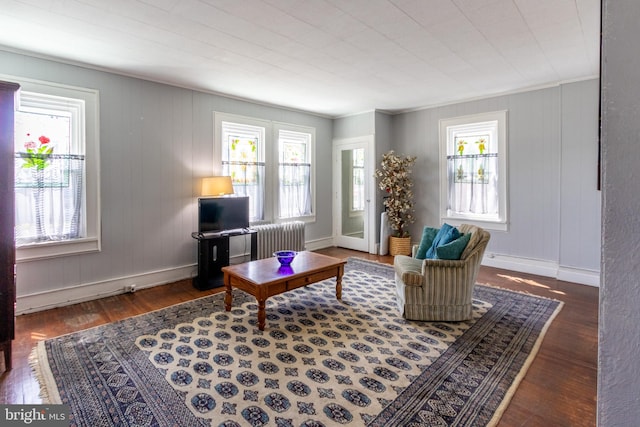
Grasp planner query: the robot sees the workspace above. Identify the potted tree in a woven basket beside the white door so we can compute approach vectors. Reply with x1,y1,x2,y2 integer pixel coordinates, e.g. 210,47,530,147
374,150,416,256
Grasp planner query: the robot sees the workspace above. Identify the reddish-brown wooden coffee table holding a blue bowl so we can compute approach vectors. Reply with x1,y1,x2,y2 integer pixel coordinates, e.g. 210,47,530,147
222,251,347,331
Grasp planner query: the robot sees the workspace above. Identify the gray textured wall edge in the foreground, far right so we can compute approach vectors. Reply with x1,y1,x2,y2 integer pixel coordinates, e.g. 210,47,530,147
598,0,640,427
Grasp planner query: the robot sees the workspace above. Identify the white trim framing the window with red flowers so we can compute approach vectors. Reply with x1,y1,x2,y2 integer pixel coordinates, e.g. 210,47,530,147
0,75,102,262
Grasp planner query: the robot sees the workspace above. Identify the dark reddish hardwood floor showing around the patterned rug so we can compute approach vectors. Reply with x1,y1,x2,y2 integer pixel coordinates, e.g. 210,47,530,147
0,248,598,427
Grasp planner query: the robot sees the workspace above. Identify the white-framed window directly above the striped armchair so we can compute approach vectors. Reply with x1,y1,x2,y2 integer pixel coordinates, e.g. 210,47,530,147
440,111,507,230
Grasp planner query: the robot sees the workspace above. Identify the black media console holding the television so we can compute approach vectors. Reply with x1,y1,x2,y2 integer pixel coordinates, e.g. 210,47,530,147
191,228,258,291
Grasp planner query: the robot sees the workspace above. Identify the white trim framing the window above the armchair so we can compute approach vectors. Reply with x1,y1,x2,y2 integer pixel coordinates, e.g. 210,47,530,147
439,110,509,231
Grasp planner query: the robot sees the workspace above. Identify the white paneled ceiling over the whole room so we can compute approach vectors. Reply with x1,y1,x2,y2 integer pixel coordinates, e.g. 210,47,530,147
0,0,600,117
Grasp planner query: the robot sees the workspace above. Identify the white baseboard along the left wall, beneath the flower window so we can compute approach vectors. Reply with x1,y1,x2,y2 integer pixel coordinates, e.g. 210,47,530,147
16,264,198,314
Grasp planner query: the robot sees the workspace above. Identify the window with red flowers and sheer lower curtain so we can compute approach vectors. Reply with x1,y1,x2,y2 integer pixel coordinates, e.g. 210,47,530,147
9,78,100,261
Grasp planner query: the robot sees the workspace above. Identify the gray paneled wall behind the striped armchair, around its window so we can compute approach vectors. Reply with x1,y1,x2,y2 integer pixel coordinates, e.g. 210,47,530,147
393,80,600,278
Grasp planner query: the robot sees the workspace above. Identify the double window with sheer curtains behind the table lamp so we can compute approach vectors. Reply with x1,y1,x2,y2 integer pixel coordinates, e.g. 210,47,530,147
214,113,315,223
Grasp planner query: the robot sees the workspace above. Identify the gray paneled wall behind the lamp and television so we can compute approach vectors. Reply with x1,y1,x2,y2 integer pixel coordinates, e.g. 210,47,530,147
0,51,333,309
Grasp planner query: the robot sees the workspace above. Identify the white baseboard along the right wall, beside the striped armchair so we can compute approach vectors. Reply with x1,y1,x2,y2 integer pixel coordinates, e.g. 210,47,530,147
482,253,600,287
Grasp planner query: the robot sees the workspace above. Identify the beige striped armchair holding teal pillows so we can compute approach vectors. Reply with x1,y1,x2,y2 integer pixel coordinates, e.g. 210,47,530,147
393,224,490,321
